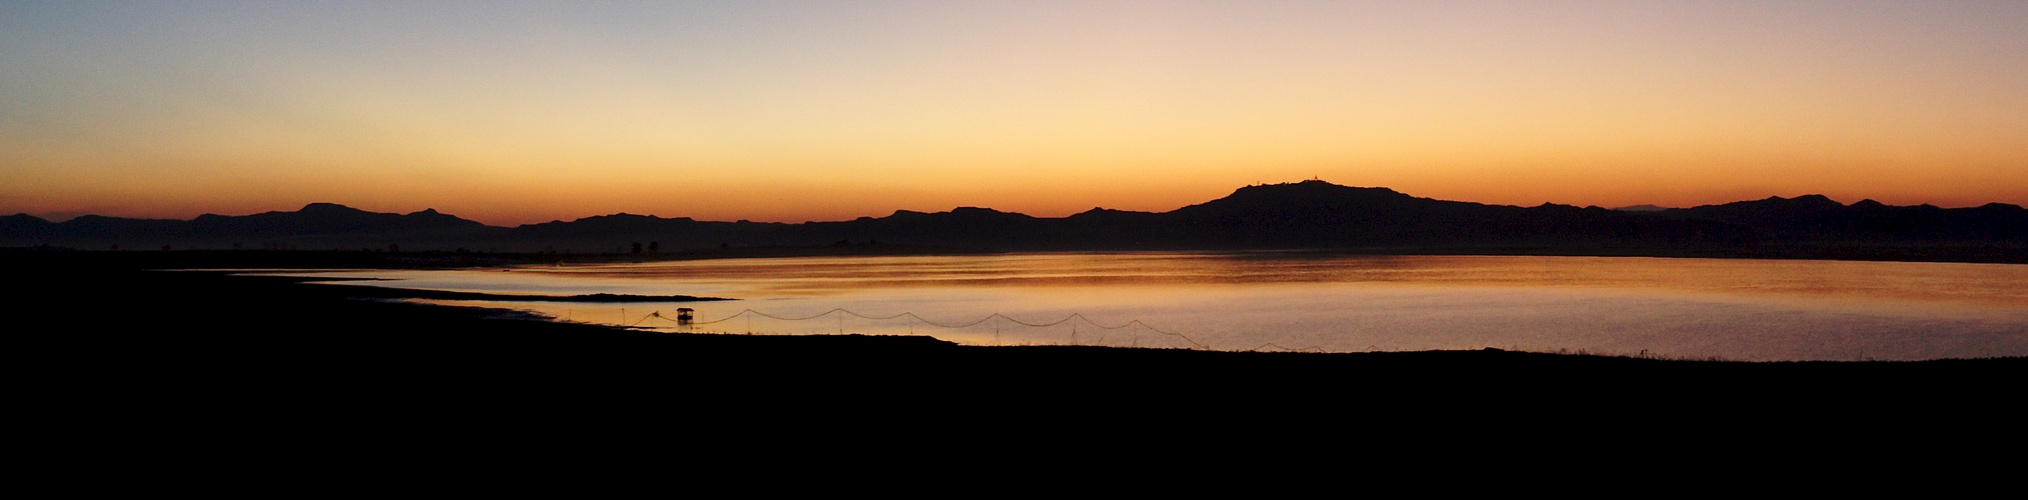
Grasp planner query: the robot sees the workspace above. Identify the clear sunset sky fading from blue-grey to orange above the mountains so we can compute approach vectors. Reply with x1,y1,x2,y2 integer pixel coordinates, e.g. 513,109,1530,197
0,0,2028,225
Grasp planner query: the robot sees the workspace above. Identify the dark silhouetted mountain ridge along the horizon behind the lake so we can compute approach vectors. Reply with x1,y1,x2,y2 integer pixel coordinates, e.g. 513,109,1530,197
0,180,2028,261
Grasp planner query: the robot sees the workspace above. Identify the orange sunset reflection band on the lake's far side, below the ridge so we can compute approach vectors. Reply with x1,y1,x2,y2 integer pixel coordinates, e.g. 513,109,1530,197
494,253,2028,308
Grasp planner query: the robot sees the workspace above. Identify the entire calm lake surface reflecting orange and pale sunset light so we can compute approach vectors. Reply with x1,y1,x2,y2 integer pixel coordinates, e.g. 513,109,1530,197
281,253,2028,360
